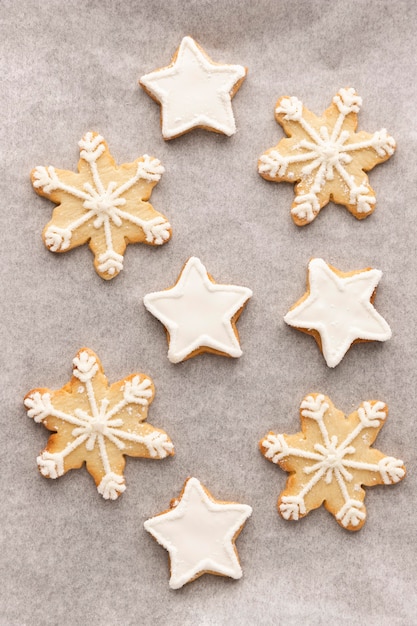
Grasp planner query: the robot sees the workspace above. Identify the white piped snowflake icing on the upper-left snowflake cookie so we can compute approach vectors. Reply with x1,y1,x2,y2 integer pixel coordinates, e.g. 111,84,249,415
33,132,170,276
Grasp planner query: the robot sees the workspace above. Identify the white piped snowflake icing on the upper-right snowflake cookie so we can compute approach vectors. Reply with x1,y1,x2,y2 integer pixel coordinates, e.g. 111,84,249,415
259,88,395,222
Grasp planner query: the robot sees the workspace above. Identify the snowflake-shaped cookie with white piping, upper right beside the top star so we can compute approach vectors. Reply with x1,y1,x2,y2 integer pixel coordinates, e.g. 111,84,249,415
258,88,395,226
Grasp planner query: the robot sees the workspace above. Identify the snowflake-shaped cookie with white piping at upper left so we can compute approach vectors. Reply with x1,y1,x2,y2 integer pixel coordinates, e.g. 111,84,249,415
31,132,171,280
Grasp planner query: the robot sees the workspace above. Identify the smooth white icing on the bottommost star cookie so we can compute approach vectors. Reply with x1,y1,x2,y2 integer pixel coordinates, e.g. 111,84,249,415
144,478,252,589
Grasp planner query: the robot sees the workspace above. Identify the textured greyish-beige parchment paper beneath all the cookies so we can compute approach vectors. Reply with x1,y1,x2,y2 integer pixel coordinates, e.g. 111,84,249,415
0,0,417,626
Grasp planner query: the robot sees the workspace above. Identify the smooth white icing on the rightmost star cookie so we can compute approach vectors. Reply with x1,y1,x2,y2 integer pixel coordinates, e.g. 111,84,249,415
284,259,391,367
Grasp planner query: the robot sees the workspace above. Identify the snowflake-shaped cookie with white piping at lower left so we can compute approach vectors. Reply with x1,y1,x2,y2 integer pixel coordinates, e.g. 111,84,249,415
24,348,174,500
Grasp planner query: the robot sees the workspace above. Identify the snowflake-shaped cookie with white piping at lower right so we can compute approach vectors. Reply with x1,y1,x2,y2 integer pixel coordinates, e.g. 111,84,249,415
260,394,405,530
